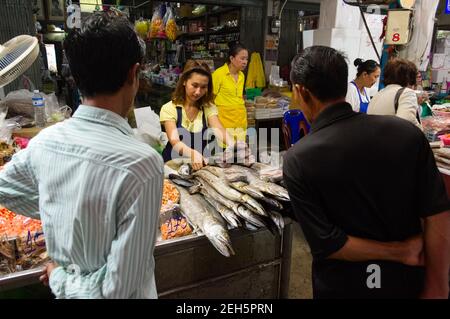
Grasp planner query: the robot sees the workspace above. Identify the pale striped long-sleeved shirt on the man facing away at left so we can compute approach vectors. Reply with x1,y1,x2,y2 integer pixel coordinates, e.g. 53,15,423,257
0,105,163,298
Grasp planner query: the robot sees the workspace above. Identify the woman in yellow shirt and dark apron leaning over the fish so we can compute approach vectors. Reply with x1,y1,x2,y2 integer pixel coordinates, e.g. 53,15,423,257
160,60,233,170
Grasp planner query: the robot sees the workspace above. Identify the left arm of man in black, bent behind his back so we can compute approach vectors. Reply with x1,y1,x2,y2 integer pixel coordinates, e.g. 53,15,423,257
283,155,422,265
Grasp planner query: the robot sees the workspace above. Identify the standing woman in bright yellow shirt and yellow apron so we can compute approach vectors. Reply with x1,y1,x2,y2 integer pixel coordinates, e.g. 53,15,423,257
212,44,248,142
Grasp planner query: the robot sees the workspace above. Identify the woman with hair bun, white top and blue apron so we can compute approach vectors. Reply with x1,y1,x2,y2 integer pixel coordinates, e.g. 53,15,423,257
346,59,381,113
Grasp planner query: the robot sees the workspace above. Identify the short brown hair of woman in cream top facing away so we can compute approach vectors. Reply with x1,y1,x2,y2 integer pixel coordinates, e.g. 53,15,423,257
383,58,419,87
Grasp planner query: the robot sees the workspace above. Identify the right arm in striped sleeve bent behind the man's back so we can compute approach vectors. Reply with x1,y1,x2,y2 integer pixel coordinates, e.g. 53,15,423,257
49,175,163,298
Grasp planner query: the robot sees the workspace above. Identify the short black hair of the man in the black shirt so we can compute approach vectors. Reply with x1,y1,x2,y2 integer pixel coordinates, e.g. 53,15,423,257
291,46,348,102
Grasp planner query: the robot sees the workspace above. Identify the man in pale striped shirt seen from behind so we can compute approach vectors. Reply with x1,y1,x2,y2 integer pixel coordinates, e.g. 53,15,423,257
0,13,163,298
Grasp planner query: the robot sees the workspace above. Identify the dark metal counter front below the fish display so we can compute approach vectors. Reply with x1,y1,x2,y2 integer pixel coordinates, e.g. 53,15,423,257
0,218,292,299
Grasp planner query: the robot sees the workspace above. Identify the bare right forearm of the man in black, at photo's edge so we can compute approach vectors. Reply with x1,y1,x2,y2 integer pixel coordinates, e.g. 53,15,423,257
421,211,450,299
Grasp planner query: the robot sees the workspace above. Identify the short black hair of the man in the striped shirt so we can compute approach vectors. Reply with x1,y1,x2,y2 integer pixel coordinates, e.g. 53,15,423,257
64,12,144,97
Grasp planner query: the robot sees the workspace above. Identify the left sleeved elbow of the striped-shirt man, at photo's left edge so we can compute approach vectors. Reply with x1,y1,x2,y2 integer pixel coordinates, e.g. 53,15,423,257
0,146,39,218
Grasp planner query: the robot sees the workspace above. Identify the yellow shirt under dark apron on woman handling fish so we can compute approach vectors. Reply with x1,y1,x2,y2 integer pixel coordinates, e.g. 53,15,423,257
159,101,218,133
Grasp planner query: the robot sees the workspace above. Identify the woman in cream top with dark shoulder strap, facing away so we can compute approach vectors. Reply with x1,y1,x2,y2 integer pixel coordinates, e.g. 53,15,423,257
367,58,422,128
